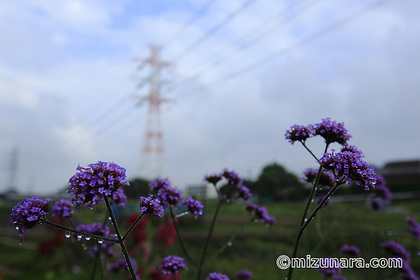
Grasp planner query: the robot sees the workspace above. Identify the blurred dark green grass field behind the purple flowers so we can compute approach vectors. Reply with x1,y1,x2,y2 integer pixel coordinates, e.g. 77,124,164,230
0,200,420,280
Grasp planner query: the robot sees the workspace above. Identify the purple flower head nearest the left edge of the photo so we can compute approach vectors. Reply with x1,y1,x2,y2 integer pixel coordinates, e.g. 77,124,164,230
11,197,51,242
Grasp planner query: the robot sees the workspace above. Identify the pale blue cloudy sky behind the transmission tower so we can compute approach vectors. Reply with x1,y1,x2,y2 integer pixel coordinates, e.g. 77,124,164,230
0,0,420,194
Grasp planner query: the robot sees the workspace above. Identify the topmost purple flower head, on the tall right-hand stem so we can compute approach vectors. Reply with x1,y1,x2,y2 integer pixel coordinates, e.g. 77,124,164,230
313,118,351,145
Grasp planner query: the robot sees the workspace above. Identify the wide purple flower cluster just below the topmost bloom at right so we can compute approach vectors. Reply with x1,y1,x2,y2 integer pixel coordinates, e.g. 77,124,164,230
319,151,376,189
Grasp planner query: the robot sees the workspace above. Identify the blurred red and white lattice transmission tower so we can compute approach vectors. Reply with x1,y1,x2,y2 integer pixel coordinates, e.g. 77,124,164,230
136,45,171,180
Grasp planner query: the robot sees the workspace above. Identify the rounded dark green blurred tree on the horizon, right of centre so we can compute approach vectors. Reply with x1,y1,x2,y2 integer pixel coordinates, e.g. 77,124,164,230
250,163,303,200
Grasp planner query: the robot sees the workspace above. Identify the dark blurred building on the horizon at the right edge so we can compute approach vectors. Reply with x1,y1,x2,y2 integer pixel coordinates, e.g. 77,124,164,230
378,160,420,192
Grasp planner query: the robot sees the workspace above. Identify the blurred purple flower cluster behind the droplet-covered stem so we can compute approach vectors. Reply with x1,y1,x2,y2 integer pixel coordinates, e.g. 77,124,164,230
72,223,115,257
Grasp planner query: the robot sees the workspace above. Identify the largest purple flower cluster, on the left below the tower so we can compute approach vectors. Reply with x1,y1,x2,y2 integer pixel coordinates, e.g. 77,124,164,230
68,161,129,210
